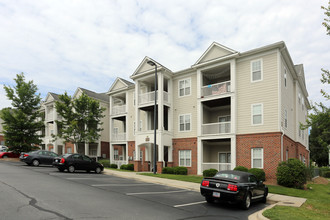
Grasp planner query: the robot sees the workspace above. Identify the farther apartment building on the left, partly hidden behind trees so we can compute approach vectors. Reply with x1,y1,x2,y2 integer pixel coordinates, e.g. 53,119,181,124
42,88,110,158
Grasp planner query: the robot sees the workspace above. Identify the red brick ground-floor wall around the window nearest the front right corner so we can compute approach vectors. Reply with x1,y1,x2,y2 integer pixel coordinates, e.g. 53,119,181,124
236,132,281,179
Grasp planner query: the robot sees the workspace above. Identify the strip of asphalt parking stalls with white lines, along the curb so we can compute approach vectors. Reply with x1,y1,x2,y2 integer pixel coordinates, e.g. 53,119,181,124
1,162,266,219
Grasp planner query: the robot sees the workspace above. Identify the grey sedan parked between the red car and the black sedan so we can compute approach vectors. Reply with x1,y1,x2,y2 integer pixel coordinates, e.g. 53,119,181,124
19,150,58,166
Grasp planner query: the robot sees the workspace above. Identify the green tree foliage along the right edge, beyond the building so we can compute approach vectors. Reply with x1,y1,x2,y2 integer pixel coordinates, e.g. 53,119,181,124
302,1,330,166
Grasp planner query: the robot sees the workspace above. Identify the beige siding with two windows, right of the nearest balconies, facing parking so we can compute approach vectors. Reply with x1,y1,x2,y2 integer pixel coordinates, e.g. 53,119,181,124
236,51,279,134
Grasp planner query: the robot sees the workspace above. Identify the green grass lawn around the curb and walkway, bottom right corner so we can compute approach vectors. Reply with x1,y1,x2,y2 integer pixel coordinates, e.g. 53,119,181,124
263,184,330,220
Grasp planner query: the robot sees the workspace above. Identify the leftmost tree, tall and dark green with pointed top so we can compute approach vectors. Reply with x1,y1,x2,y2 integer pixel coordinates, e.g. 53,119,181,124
0,73,44,153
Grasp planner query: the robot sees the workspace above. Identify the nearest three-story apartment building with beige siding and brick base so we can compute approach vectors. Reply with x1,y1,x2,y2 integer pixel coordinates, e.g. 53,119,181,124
107,42,310,178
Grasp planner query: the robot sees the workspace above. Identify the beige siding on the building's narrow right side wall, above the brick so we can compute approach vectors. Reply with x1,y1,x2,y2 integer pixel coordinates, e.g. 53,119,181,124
280,56,297,140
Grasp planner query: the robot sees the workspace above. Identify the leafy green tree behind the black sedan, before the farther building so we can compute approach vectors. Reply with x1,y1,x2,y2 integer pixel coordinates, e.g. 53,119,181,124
55,92,105,150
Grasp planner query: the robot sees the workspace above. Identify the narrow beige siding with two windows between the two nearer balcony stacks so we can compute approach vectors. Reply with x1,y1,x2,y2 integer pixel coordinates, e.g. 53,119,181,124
173,72,197,138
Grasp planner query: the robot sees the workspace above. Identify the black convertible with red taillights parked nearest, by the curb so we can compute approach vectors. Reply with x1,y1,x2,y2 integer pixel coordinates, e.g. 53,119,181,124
200,170,268,209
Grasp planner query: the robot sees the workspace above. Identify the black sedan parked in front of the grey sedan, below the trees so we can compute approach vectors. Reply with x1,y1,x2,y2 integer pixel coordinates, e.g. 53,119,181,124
53,154,104,173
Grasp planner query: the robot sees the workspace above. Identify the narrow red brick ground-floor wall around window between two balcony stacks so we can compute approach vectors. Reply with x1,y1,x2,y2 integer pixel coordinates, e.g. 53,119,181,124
172,138,197,175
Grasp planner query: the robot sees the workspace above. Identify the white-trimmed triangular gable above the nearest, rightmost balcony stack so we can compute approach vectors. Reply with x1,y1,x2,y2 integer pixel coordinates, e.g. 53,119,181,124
194,42,238,65
